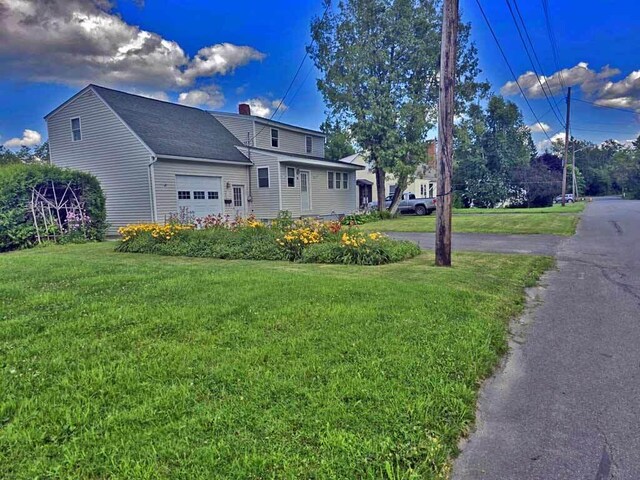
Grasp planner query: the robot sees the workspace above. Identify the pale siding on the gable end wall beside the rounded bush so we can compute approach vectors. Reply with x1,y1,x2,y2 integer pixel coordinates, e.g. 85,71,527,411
47,90,152,235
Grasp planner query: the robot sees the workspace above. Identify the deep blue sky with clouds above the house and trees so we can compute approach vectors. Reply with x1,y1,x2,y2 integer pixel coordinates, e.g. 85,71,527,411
0,0,640,150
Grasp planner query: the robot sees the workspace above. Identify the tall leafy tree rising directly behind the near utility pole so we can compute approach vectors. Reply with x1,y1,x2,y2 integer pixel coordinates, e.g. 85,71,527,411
309,0,488,209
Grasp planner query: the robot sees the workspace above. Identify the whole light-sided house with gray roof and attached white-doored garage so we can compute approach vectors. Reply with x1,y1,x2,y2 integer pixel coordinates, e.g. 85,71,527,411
45,85,361,233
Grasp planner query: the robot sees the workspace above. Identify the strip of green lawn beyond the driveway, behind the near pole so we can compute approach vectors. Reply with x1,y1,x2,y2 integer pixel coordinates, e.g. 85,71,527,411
362,206,580,235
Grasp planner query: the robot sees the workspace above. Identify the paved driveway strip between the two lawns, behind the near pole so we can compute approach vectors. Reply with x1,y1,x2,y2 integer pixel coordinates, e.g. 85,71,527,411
389,232,568,255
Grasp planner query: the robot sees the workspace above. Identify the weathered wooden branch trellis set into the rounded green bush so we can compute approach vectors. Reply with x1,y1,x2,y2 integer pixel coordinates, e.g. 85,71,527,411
29,181,87,243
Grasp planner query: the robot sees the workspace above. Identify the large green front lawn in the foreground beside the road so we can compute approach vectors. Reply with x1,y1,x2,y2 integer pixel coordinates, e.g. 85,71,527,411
0,243,552,479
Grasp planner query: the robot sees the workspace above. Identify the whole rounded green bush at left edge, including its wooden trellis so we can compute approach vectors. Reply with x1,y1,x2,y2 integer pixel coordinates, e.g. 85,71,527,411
0,164,107,251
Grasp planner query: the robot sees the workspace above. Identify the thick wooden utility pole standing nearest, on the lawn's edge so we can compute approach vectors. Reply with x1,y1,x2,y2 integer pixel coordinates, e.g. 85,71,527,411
436,0,458,267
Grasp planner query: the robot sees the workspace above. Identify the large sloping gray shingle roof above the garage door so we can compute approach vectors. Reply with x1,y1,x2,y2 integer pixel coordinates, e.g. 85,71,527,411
90,85,250,164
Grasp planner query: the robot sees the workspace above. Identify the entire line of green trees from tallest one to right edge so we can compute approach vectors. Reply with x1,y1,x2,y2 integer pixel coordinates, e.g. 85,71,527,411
308,0,637,212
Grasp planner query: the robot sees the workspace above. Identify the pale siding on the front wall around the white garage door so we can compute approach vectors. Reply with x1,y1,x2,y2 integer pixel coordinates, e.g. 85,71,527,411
154,158,249,223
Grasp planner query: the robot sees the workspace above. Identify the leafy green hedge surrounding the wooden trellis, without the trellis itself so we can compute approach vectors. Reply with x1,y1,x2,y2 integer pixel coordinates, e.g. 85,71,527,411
0,164,107,251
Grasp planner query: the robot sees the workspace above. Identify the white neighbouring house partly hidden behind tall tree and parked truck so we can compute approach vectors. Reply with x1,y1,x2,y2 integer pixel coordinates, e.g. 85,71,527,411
340,149,437,209
